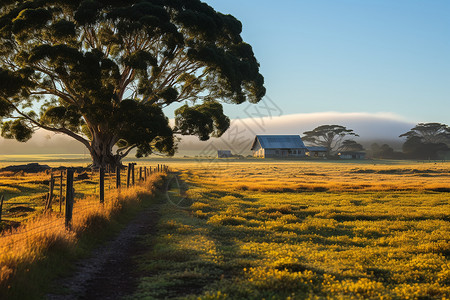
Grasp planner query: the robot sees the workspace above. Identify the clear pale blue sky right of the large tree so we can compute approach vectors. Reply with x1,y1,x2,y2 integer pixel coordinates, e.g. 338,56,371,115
200,0,450,124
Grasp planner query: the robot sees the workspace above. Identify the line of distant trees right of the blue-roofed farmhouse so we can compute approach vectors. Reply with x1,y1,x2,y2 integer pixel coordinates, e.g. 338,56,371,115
303,123,450,160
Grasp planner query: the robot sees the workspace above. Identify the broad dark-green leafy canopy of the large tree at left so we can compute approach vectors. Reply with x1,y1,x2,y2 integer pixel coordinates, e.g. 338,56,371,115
0,0,265,166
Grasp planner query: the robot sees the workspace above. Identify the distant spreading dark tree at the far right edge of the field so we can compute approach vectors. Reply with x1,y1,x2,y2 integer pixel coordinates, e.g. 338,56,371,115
400,123,450,159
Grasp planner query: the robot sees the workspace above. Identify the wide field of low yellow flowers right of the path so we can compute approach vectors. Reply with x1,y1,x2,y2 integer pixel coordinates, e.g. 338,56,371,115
133,161,450,299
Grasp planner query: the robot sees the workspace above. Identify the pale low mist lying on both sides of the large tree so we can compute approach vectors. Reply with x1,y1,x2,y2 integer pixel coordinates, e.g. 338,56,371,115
0,112,416,156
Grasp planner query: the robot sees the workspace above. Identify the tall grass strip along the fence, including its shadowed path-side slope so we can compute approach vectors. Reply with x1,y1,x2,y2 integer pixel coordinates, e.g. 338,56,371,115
0,174,165,299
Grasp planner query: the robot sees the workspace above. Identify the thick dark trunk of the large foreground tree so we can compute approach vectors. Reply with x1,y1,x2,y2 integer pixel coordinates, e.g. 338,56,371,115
89,138,122,170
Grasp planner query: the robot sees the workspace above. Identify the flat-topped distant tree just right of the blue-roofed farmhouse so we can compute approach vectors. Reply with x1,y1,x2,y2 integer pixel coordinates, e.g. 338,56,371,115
302,125,359,156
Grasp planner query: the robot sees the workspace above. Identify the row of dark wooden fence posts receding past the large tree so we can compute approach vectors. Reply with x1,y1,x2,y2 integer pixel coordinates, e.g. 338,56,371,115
0,163,169,229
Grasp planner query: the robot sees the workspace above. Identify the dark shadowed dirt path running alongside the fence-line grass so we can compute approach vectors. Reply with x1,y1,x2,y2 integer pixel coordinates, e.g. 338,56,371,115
47,203,159,300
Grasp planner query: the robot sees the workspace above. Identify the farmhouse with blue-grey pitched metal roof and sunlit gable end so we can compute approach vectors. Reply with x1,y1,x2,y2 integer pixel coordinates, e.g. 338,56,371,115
251,135,307,158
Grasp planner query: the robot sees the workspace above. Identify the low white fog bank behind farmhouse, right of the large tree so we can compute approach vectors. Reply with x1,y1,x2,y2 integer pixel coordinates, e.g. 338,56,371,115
179,112,415,156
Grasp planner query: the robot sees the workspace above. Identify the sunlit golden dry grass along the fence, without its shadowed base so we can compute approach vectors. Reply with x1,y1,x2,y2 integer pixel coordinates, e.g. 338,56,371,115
0,173,164,297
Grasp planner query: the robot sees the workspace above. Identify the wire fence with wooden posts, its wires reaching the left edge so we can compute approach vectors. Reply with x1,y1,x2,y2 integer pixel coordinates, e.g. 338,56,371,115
0,163,169,256
